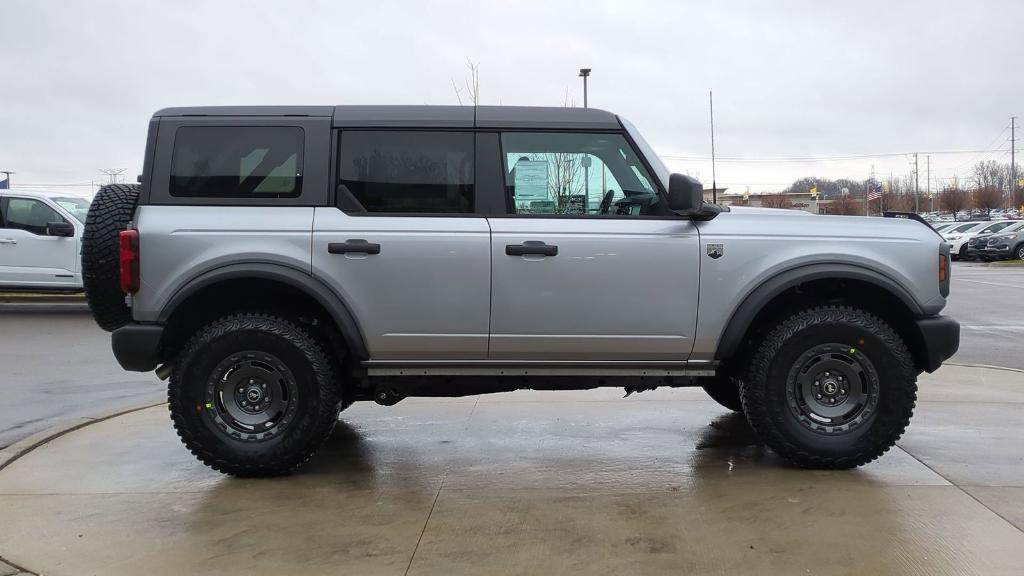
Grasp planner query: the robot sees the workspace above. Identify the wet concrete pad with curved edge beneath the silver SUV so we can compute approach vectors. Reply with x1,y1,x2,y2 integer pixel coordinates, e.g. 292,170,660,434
0,366,1024,576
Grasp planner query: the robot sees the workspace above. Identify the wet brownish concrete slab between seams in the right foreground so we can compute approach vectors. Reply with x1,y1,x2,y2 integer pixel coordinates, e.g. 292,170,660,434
410,484,1024,576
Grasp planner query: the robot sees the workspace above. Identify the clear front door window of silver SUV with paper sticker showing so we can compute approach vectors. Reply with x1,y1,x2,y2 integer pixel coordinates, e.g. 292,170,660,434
502,132,660,216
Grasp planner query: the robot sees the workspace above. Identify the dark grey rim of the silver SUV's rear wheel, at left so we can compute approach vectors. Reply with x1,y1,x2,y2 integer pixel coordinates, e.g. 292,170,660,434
206,351,298,441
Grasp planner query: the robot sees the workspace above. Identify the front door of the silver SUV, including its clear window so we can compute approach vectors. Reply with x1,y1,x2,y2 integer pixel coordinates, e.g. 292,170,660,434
489,132,699,362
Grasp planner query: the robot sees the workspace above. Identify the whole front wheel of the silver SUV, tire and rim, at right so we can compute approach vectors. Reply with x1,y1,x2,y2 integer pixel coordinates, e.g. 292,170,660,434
740,305,918,468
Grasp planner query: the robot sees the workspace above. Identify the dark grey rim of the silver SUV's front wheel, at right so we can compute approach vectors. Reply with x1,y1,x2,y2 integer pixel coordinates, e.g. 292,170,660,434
786,342,880,435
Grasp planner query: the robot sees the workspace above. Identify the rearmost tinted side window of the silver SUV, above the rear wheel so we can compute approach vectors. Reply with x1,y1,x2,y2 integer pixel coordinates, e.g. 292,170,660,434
170,126,303,198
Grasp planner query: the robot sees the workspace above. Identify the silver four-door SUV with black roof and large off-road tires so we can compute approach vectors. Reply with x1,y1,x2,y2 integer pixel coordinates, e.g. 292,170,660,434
83,107,959,476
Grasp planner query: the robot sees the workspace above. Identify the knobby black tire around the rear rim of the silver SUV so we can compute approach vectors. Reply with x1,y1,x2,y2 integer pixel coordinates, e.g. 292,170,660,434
167,313,342,477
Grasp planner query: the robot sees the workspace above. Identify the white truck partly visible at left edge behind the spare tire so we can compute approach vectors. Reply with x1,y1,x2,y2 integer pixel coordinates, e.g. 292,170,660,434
0,190,89,291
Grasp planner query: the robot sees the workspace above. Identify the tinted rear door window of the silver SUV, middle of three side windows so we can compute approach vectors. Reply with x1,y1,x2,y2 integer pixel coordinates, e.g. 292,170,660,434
338,130,473,214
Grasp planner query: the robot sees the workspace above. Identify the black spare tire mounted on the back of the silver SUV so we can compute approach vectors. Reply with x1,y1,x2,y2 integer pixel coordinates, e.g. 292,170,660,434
82,184,138,332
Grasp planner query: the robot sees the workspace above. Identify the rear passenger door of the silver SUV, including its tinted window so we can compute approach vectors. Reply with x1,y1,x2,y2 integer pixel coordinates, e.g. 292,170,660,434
312,129,490,361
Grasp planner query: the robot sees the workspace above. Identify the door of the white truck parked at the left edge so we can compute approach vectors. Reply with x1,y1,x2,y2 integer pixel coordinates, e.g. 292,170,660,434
0,196,81,288
